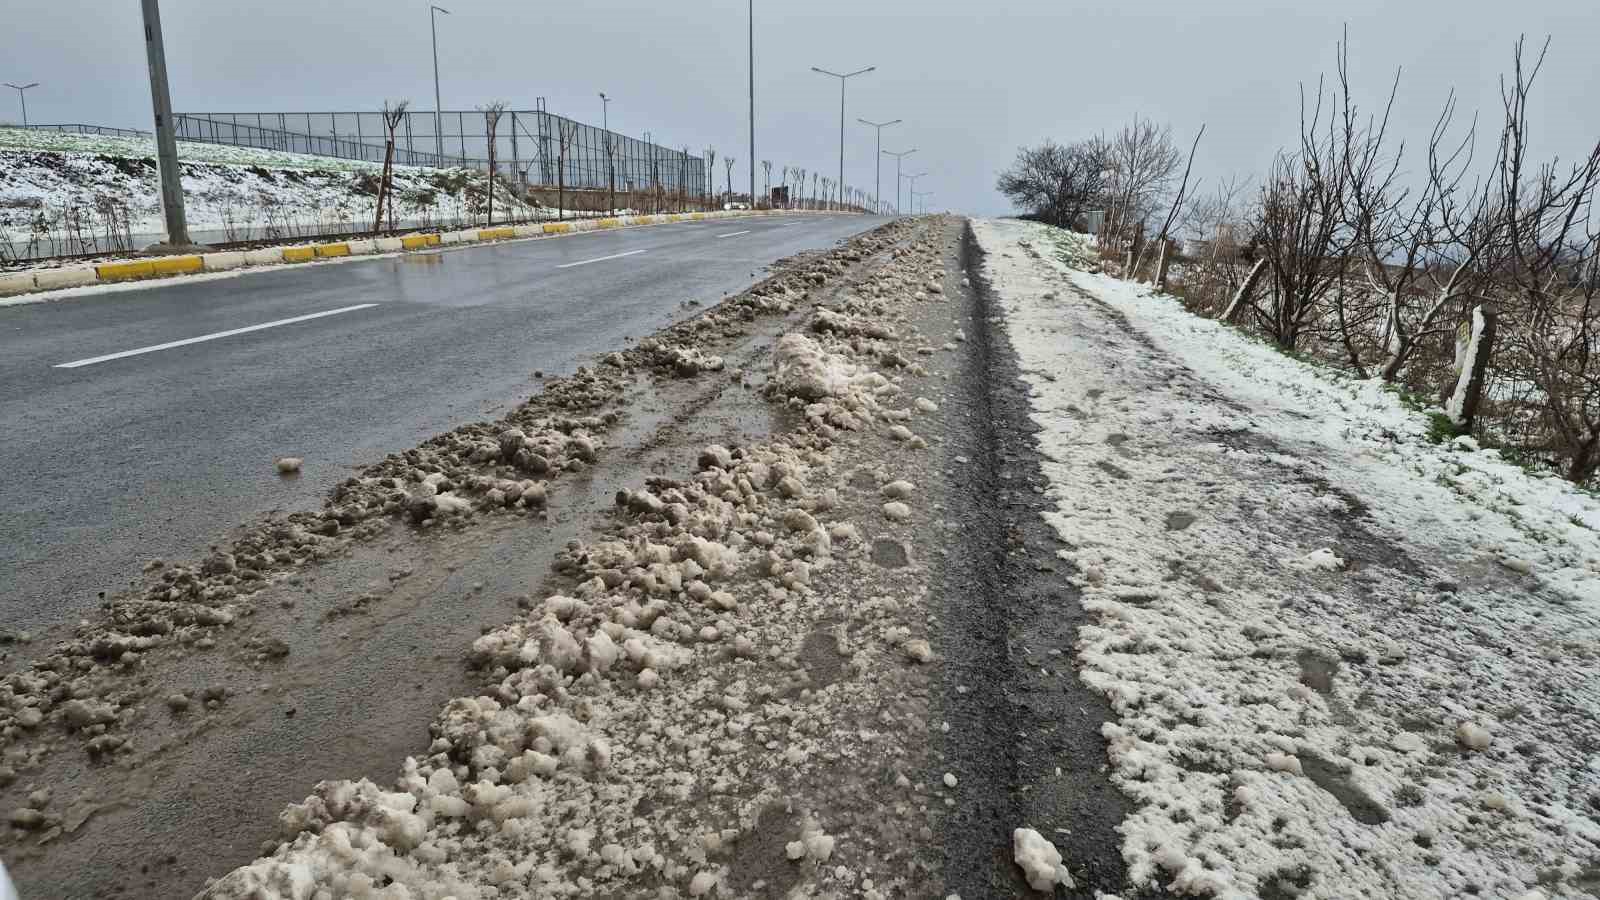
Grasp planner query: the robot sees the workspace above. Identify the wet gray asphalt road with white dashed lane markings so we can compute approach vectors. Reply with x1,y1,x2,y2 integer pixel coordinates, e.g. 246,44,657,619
0,215,883,634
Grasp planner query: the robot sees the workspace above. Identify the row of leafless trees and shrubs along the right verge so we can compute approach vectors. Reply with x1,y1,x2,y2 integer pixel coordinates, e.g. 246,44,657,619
1017,31,1600,482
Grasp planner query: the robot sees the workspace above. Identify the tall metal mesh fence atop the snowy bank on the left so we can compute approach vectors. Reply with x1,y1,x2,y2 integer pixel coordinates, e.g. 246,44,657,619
173,104,707,199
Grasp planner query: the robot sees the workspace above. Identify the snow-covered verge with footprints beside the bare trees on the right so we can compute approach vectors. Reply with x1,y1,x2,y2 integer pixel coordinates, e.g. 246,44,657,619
974,219,1600,898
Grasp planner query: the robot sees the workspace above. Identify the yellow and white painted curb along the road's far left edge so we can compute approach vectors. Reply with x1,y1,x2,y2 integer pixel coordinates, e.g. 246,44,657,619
0,210,851,296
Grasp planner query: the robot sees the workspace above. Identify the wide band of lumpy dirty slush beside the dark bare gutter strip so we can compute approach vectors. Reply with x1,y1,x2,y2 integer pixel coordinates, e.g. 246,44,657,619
188,216,946,900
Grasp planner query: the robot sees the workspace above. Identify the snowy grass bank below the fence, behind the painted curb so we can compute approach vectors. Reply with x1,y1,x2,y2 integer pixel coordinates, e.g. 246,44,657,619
0,128,555,259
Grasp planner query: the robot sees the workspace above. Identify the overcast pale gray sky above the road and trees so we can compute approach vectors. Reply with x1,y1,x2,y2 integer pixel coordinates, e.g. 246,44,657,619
0,0,1600,213
